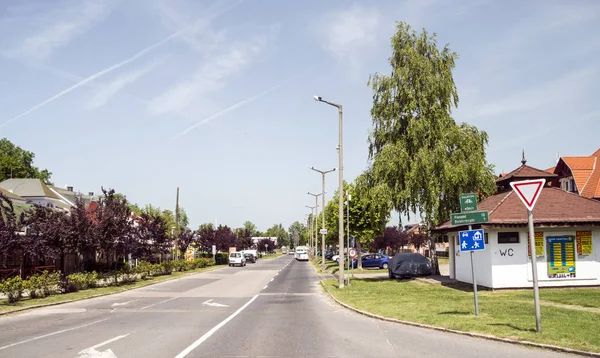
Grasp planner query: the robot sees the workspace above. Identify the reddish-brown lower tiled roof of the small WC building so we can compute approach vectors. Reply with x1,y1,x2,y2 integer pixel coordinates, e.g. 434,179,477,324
435,187,600,231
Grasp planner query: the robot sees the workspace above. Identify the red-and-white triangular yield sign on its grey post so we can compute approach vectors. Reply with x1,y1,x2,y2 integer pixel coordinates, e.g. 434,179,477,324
510,179,546,333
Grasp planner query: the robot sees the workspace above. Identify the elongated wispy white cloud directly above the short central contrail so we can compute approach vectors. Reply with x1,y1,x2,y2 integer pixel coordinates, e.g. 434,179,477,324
148,31,271,115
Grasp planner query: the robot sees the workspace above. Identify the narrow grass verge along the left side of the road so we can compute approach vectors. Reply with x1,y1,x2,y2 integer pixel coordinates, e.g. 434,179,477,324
0,265,223,313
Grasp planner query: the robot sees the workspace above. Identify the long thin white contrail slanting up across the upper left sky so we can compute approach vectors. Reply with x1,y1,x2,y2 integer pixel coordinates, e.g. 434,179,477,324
0,0,244,128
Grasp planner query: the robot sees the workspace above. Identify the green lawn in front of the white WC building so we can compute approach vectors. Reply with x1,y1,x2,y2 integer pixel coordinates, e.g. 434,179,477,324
324,279,600,352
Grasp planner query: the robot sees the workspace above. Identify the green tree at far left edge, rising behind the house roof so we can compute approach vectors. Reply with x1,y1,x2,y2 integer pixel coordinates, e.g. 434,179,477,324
0,138,52,184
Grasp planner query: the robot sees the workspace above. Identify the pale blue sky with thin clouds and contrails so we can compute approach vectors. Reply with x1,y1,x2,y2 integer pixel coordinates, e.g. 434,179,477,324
0,0,600,230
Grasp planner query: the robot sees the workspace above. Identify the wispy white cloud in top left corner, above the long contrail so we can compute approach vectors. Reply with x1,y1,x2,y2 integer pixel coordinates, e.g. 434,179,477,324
11,0,108,61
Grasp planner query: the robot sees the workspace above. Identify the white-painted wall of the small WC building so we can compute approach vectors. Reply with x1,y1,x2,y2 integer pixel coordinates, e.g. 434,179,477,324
449,227,600,288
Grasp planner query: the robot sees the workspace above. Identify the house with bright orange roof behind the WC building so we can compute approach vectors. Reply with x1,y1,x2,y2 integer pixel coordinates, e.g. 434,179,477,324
553,149,600,200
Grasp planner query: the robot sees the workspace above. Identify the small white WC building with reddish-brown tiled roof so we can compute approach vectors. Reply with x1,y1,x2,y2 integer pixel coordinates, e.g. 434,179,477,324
434,160,600,288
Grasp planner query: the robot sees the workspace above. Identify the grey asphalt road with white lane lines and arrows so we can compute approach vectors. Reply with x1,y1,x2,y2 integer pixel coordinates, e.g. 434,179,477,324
0,256,562,358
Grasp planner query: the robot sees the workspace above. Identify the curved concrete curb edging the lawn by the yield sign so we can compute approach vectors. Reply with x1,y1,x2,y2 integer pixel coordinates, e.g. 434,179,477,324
320,281,600,358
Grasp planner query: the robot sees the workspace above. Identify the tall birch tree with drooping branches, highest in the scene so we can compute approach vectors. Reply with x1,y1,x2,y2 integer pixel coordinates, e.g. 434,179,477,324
368,23,495,272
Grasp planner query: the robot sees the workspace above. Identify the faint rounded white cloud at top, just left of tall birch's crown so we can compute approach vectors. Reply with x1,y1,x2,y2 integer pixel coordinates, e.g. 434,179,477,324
316,4,381,65
